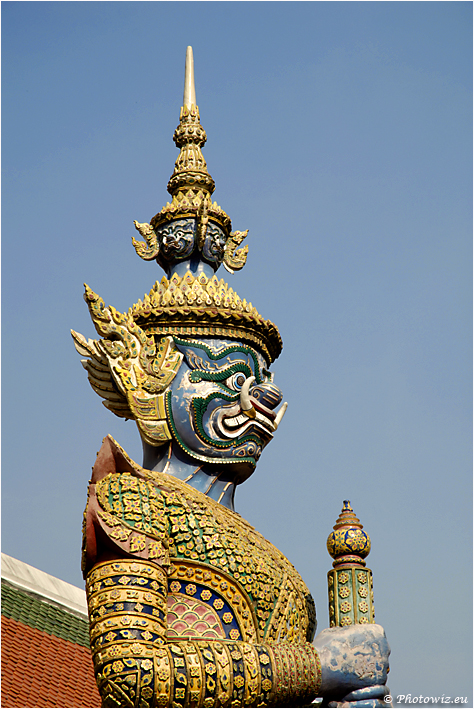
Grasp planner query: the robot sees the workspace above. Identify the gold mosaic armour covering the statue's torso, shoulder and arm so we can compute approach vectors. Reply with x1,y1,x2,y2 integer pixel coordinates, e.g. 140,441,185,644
83,437,320,706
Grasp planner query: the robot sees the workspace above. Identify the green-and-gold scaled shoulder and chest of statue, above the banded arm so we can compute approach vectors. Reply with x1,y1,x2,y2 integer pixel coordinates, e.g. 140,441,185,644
87,448,309,642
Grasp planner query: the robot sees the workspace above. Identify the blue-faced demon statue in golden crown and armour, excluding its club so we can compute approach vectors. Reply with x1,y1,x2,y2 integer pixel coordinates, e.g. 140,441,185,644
73,47,389,707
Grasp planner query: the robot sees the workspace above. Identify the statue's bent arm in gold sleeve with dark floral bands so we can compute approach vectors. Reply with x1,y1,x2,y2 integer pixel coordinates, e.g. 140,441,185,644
87,560,321,707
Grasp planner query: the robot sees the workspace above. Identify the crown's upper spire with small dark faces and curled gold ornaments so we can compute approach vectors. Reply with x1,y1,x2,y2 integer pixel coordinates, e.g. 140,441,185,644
133,47,248,277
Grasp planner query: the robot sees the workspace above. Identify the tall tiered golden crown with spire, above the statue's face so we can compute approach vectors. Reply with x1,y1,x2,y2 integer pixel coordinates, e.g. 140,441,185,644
129,47,282,361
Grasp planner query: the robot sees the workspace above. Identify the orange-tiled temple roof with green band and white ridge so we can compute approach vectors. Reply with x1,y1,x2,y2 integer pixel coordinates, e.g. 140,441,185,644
2,554,101,707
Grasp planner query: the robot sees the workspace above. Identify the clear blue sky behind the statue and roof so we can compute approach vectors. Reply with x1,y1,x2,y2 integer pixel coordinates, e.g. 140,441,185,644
2,2,472,706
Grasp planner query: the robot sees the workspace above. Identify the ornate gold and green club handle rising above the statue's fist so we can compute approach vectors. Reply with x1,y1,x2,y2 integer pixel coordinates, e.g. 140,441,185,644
327,500,375,628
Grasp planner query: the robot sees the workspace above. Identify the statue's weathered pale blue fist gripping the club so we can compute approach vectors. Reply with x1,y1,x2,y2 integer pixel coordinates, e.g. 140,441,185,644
314,624,390,707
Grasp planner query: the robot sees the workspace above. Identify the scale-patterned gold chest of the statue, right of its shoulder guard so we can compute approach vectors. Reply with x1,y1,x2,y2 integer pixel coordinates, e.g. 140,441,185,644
152,474,316,642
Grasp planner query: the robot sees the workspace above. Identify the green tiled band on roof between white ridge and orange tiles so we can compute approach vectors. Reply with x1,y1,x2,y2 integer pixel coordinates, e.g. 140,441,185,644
2,581,90,647
